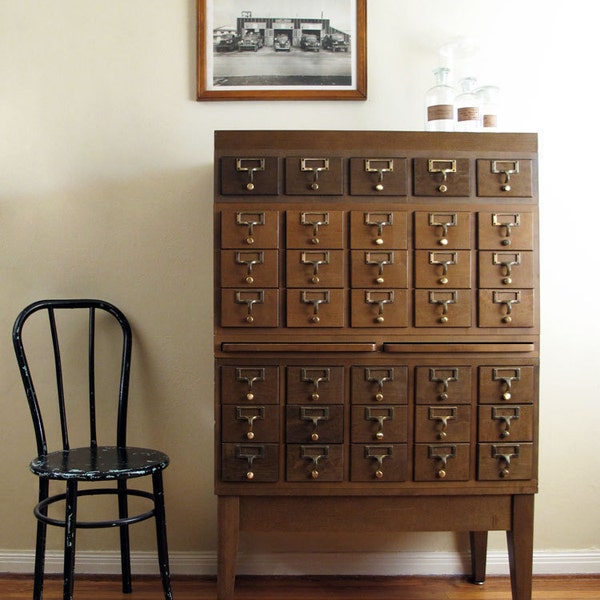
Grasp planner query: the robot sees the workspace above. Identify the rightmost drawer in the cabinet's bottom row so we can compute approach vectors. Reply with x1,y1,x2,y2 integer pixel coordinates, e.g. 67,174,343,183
477,443,533,481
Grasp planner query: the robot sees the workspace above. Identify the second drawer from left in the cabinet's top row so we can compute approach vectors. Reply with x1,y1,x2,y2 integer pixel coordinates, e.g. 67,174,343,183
285,156,344,196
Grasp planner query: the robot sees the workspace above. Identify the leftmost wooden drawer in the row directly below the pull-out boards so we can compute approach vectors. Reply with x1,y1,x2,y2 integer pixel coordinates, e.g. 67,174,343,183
221,365,279,404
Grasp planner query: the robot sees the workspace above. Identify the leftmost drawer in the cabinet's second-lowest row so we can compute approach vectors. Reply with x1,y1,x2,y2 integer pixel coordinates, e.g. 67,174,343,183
221,404,279,443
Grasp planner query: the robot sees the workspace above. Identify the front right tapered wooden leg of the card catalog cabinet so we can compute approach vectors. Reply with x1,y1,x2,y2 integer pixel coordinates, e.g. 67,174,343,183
506,494,533,600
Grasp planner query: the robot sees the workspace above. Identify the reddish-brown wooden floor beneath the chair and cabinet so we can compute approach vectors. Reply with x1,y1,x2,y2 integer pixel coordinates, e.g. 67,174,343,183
0,575,600,600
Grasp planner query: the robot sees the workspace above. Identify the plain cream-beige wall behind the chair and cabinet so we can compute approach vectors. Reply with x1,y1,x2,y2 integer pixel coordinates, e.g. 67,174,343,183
0,0,600,568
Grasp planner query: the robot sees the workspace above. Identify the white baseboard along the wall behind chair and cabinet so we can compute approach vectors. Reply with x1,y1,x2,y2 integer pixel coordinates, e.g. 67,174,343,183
0,550,600,576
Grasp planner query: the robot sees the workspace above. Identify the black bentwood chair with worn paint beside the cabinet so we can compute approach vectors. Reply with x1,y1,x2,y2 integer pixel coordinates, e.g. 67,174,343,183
13,300,173,600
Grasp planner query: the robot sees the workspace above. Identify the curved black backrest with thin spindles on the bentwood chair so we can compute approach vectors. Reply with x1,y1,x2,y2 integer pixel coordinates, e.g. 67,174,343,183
13,300,131,455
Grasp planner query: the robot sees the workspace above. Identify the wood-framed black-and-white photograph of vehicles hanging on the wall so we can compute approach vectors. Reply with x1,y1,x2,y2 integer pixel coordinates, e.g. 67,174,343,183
197,0,367,100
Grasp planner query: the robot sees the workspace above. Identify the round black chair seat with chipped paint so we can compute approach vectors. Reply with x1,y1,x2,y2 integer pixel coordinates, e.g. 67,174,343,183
30,446,169,481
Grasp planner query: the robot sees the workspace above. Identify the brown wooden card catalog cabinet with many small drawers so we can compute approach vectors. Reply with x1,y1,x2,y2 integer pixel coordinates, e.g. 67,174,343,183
214,131,539,600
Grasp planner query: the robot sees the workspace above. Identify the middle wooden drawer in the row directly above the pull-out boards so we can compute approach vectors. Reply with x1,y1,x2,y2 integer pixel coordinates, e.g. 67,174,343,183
351,289,408,327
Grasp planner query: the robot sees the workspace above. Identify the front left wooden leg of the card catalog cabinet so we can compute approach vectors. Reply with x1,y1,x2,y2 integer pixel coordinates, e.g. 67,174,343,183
217,496,240,600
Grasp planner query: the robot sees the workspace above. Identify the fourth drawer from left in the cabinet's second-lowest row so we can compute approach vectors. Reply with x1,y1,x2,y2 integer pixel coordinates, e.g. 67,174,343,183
415,404,471,443
